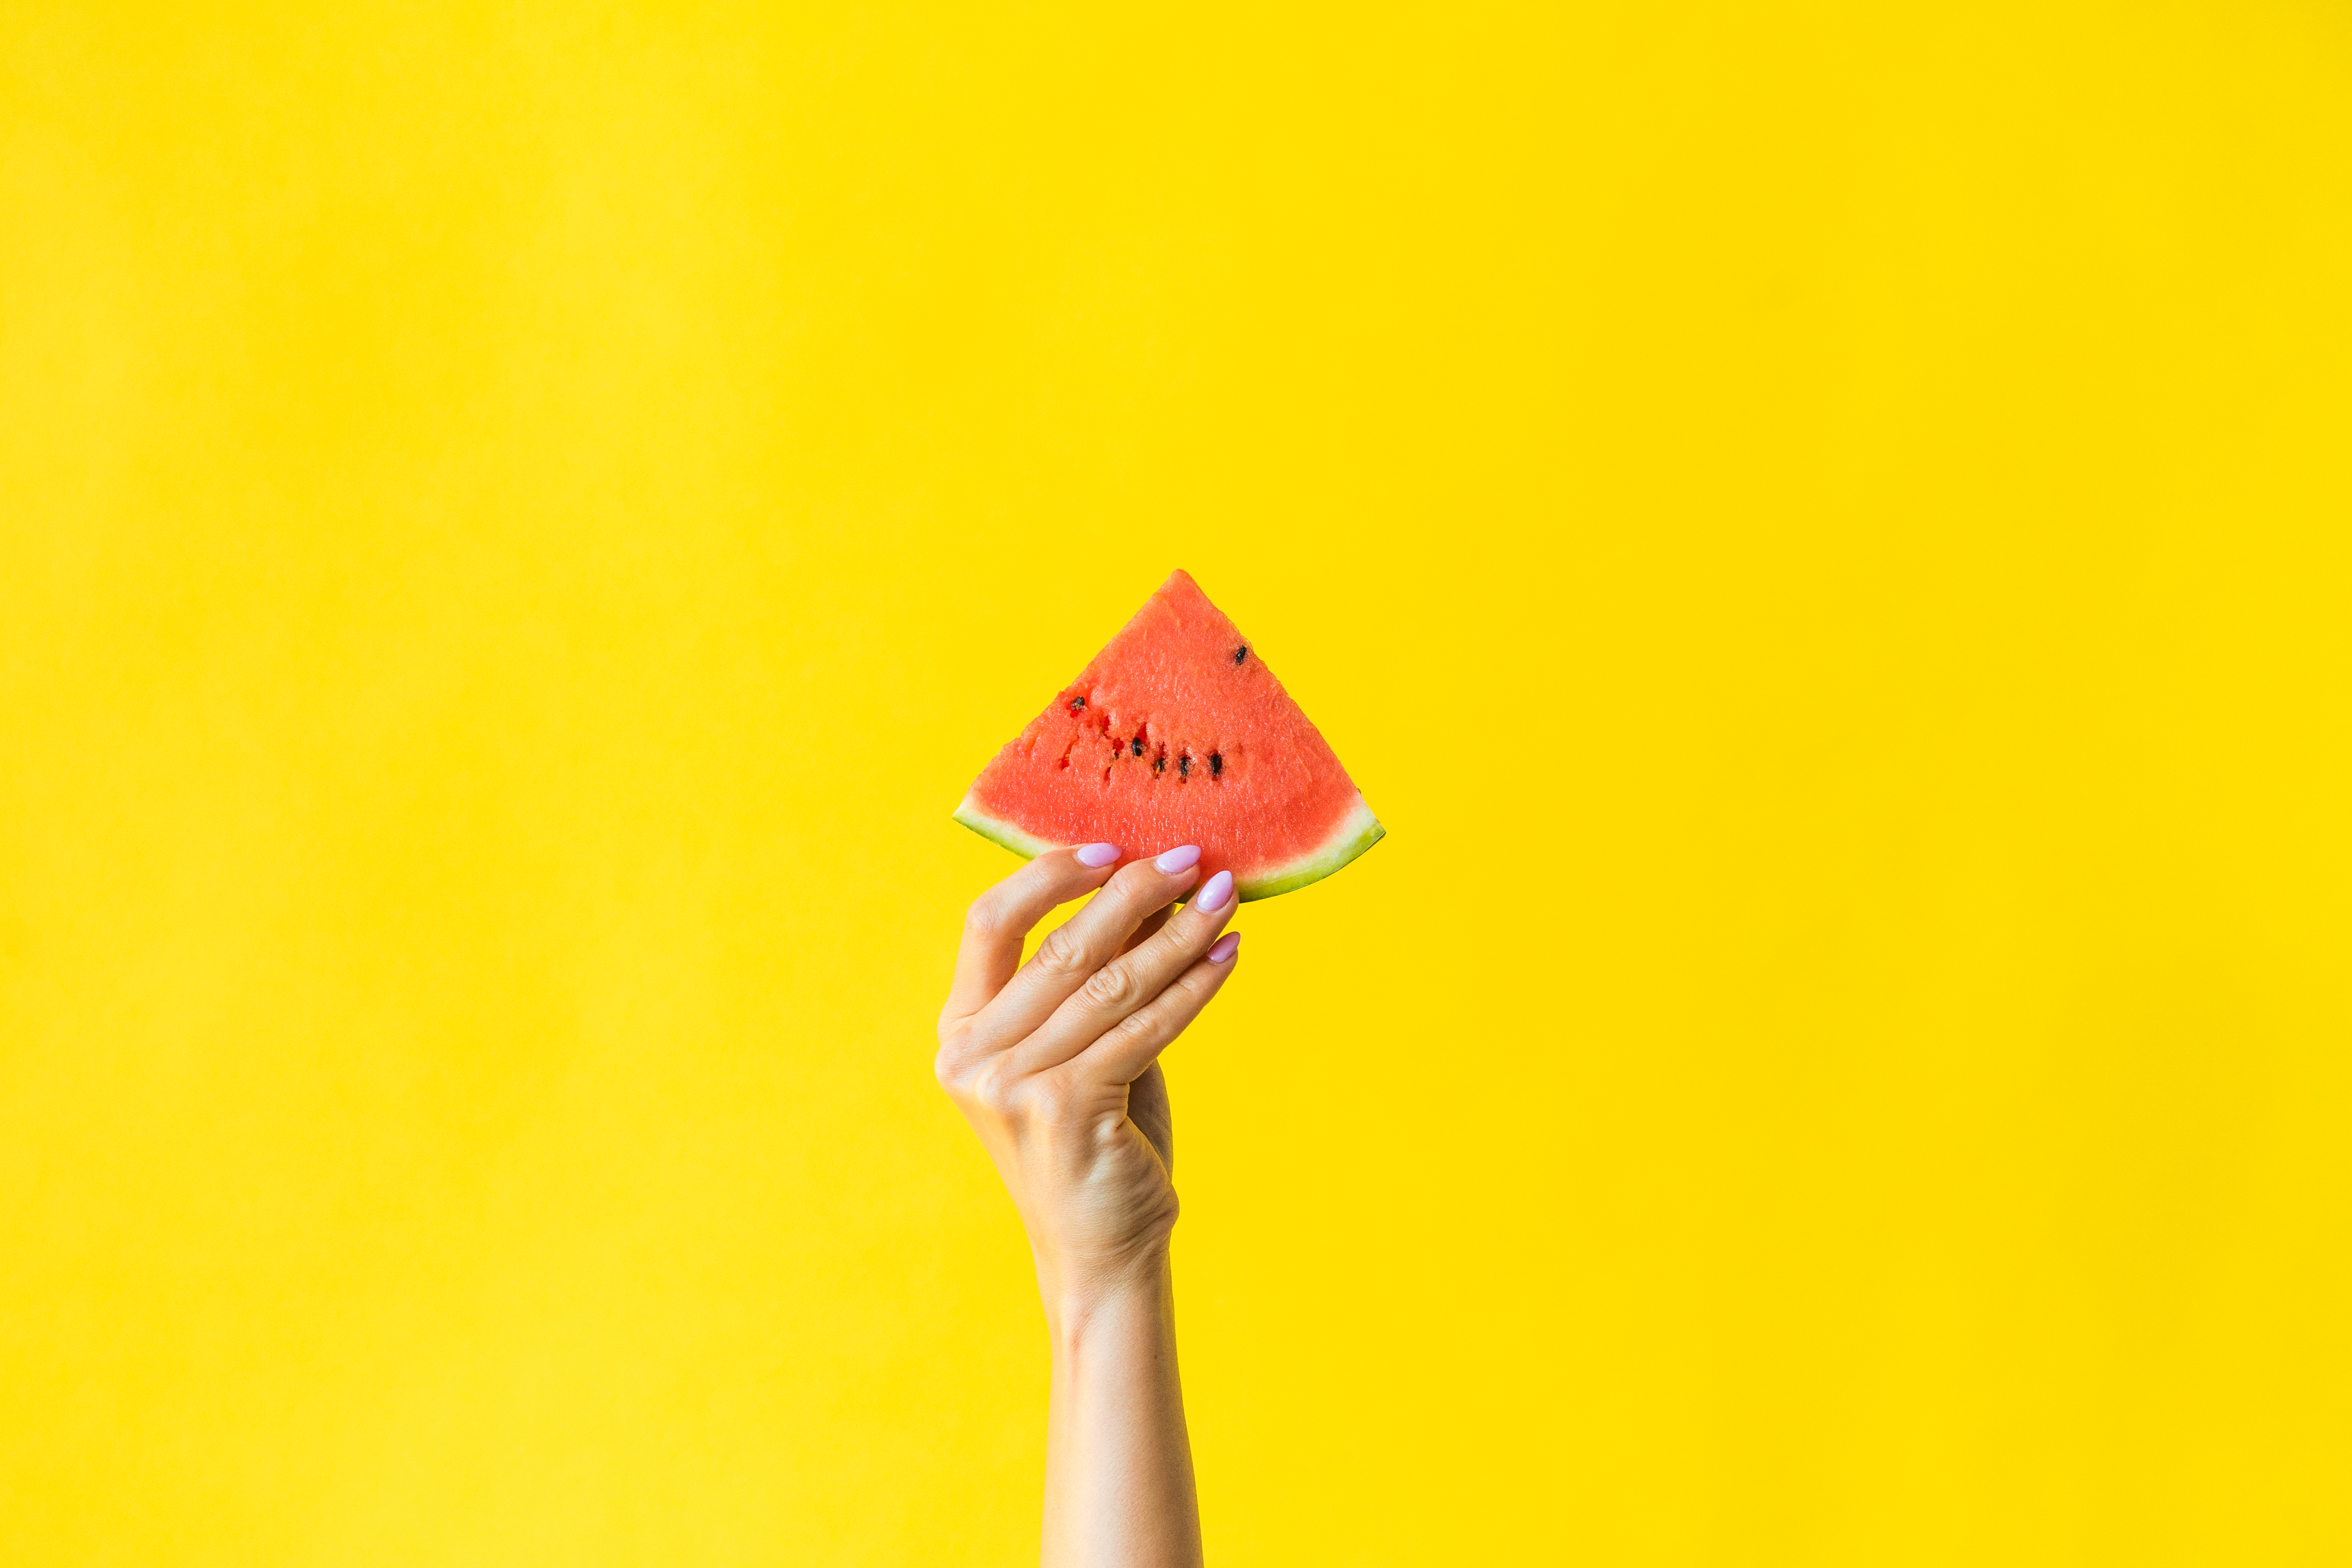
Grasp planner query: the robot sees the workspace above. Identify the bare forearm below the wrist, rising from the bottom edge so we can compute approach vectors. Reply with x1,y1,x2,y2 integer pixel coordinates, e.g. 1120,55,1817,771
1044,1250,1200,1568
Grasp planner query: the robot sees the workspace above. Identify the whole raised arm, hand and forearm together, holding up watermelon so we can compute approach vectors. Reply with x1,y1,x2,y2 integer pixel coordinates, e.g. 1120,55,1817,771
938,844,1242,1568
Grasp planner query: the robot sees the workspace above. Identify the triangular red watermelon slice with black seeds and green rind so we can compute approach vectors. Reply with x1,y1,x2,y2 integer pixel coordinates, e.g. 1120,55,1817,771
955,571,1388,898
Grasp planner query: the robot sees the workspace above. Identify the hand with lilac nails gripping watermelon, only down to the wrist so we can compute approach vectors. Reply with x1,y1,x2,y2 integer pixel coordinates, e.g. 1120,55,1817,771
938,844,1242,1323
